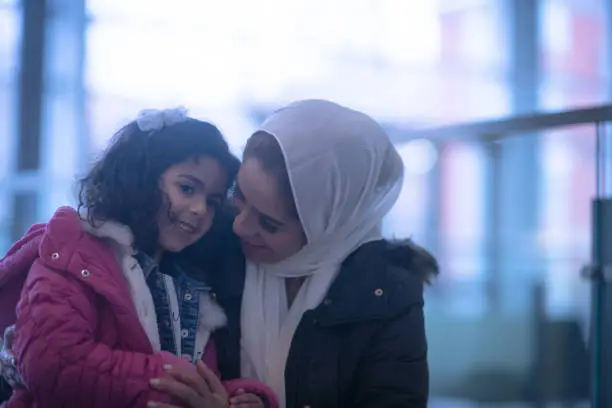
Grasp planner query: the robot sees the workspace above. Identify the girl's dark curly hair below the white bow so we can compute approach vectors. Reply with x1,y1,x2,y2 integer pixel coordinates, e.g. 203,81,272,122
78,118,240,254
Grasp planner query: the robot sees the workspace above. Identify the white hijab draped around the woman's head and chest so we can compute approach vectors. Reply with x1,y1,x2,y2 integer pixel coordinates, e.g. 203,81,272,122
241,100,404,407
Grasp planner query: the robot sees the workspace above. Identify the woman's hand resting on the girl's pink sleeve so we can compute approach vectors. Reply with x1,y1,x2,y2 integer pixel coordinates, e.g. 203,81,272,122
148,360,229,408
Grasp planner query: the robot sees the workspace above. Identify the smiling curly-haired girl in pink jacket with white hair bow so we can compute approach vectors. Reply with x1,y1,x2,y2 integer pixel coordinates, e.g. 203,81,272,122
0,109,276,408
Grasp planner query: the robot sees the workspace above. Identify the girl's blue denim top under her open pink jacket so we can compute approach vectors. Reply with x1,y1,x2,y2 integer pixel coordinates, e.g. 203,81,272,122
136,253,210,361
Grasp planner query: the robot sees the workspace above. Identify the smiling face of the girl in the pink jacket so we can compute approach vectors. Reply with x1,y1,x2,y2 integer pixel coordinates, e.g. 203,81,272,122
151,157,228,254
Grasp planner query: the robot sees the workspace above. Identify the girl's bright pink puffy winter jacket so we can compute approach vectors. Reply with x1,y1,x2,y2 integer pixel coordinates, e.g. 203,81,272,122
0,207,277,408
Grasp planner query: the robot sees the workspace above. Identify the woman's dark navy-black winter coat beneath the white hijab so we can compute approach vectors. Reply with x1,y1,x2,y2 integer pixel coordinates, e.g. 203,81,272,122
184,212,438,408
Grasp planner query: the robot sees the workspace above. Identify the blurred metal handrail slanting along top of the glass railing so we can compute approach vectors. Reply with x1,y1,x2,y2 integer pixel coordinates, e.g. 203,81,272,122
392,105,612,143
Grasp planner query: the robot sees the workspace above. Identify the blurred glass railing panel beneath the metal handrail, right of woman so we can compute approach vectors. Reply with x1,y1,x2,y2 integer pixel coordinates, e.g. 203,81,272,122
387,105,612,408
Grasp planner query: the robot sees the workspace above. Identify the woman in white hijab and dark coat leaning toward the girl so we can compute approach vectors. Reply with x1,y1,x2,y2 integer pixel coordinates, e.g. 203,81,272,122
152,100,438,408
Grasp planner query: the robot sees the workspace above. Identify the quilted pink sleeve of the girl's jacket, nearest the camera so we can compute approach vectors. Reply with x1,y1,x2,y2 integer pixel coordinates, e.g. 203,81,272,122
13,264,189,408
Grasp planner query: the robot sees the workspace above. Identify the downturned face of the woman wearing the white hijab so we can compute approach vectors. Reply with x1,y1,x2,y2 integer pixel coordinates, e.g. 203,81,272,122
234,158,306,264
